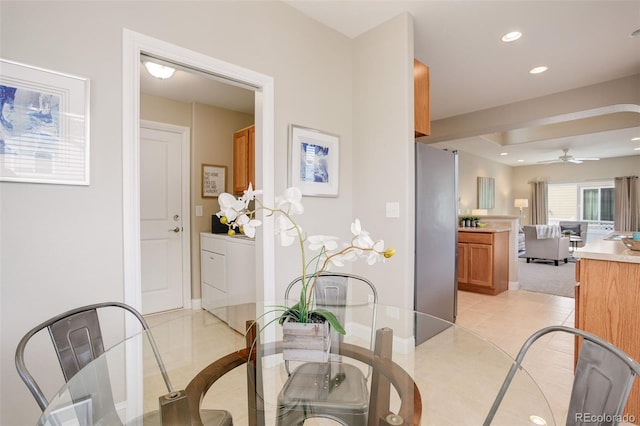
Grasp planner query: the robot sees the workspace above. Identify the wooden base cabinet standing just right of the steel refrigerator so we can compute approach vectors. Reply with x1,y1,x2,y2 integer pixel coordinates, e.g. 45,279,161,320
458,231,509,295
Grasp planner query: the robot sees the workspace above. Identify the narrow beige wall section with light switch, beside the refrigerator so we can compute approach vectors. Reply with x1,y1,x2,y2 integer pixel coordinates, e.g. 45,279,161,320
352,14,415,308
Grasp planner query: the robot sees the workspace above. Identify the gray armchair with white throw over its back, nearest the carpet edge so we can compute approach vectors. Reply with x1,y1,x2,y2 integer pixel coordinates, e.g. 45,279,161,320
522,225,569,266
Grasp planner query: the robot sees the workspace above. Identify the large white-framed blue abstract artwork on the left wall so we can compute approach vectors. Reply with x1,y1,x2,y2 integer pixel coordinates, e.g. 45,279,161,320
0,59,89,185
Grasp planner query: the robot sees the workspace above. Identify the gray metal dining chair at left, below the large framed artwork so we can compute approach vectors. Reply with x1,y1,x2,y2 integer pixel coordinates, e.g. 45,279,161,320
15,302,232,426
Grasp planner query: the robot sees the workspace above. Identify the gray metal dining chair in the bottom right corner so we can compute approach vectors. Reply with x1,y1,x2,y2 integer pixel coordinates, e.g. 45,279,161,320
484,326,640,426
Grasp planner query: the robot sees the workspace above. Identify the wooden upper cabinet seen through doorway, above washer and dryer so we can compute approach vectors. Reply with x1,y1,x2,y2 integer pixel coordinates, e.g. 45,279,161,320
233,126,256,194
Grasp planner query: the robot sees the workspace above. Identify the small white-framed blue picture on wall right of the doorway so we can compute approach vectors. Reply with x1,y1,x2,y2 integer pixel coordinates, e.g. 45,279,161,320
289,124,340,197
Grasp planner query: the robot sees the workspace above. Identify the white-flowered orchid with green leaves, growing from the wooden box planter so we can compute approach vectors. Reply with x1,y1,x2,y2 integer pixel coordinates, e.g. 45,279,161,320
217,184,395,340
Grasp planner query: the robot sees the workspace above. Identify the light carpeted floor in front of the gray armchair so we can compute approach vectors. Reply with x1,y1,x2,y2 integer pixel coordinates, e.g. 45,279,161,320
518,258,576,297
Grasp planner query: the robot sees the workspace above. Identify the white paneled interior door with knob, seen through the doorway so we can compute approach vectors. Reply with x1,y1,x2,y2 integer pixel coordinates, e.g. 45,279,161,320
140,122,190,314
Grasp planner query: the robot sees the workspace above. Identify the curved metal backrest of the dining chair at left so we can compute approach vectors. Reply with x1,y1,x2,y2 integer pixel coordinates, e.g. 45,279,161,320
15,302,173,411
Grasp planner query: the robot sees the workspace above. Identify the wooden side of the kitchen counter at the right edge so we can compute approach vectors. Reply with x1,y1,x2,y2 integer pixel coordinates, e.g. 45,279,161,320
575,258,640,419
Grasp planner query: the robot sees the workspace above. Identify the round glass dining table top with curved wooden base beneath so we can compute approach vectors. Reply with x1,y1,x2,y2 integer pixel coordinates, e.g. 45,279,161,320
38,303,555,426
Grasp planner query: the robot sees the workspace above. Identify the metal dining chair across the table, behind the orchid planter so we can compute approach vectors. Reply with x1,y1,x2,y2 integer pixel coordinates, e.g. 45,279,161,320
276,272,378,426
